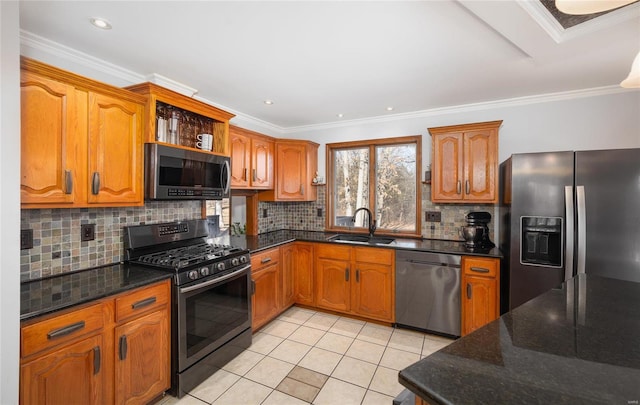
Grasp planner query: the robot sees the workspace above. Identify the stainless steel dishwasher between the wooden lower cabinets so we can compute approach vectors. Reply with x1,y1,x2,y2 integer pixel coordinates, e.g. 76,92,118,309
396,250,461,336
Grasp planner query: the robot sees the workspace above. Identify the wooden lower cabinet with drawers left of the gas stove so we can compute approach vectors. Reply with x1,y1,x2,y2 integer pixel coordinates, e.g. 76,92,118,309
20,280,171,405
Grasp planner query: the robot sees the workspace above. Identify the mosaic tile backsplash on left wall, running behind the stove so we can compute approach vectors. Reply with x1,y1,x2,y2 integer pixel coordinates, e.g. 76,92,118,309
20,201,202,281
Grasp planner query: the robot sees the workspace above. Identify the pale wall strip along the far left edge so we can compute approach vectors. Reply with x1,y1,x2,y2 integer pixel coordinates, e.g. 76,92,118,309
0,0,20,404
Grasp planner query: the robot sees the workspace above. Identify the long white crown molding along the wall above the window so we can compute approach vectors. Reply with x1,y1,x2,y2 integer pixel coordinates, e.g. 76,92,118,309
283,86,633,134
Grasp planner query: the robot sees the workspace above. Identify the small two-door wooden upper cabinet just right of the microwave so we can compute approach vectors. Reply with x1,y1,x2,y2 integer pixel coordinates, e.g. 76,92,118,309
229,125,275,190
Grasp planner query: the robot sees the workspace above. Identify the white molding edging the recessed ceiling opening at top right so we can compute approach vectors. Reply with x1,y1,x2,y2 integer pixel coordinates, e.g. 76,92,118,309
517,0,640,43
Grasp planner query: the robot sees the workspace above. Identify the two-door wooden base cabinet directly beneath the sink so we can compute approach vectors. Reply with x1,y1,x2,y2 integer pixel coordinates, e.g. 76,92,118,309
315,244,395,322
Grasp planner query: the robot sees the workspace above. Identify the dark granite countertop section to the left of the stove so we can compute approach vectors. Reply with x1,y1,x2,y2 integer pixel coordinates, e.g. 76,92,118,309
20,264,173,321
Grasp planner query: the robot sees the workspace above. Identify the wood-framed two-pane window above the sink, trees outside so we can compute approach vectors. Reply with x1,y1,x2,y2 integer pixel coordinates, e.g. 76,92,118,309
327,136,421,236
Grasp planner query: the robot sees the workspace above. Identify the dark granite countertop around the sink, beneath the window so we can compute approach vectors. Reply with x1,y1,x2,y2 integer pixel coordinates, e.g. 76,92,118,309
230,230,502,258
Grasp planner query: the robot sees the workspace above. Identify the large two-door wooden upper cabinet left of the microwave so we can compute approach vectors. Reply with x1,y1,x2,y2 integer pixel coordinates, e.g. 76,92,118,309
20,58,146,208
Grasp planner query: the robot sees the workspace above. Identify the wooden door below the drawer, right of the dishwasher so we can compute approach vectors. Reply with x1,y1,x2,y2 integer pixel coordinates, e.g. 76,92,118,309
462,276,499,335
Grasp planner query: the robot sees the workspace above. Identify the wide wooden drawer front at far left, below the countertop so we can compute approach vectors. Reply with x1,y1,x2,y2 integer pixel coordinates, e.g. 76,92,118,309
20,304,104,357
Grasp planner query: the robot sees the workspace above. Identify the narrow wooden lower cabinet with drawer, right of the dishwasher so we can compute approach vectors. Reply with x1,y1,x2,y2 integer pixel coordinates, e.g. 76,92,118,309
461,256,500,336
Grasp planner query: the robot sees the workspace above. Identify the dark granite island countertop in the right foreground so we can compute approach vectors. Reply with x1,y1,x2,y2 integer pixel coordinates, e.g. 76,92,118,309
399,274,640,405
